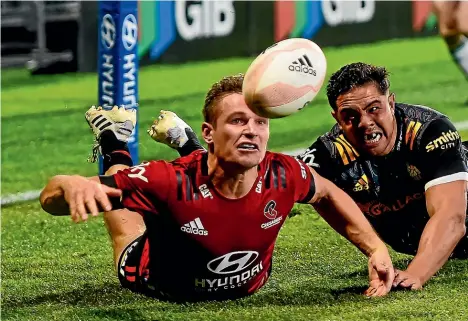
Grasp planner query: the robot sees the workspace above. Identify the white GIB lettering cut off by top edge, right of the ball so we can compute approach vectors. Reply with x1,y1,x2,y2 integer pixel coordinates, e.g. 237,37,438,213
322,0,375,26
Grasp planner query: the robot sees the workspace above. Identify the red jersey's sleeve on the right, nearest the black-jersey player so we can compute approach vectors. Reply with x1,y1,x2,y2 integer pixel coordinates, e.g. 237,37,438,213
282,155,315,203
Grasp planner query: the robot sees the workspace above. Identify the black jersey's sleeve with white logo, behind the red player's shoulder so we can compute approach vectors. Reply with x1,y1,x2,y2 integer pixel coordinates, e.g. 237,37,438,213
296,138,336,181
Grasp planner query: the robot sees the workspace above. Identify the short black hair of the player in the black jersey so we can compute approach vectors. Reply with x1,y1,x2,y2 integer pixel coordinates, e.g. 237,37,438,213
327,62,390,109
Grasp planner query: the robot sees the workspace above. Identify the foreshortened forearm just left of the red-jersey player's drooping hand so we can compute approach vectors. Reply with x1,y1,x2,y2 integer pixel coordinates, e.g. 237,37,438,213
39,175,70,215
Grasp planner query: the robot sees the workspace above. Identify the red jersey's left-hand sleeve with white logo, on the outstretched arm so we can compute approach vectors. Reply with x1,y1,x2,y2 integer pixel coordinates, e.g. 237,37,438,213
100,161,170,215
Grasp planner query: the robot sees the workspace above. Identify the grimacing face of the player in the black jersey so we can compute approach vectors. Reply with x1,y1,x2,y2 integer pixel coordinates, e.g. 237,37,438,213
332,83,397,156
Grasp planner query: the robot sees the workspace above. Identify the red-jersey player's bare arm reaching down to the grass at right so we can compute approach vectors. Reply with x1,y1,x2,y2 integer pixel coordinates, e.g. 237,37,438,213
309,168,394,296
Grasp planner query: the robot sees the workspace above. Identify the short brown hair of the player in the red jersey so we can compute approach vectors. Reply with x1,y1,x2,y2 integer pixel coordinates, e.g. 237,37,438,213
203,74,244,123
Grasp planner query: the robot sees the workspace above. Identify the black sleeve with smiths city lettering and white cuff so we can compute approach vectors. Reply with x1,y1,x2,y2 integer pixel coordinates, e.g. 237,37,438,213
417,118,468,190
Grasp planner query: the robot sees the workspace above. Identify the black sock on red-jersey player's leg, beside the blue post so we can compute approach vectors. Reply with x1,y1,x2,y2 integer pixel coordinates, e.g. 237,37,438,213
99,130,133,173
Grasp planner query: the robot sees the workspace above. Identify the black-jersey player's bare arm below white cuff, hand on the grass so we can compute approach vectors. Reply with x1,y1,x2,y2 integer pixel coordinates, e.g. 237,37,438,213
394,180,467,290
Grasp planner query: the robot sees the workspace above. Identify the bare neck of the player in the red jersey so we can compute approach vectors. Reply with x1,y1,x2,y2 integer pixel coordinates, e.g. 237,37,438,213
208,154,258,198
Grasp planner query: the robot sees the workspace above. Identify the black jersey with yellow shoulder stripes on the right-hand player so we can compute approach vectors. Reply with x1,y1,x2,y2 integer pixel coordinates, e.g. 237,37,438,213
298,104,468,256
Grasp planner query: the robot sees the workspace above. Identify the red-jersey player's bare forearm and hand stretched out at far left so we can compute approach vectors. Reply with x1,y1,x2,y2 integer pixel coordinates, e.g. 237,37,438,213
40,175,122,222
